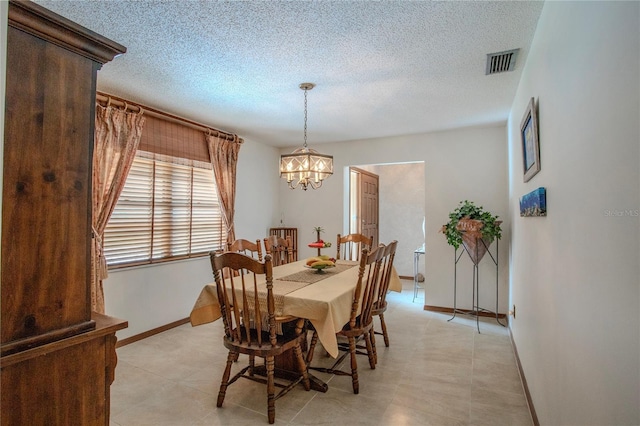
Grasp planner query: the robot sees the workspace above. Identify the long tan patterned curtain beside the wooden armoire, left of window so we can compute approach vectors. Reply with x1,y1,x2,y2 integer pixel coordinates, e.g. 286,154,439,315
91,104,145,313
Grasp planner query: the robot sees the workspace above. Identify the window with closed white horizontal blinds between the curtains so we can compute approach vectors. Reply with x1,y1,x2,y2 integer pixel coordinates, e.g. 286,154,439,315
104,151,226,267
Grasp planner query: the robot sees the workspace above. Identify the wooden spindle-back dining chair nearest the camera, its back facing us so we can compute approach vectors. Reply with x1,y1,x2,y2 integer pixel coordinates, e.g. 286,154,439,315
210,252,311,423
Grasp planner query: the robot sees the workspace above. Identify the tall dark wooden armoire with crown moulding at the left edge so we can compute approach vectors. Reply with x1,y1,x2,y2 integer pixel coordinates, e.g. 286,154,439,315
0,0,127,425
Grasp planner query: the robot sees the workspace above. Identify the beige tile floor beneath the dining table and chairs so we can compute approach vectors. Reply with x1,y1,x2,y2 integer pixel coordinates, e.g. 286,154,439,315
110,281,532,426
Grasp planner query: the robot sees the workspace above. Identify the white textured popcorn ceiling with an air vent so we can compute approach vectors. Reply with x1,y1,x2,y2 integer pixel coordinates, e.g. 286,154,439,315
36,0,543,147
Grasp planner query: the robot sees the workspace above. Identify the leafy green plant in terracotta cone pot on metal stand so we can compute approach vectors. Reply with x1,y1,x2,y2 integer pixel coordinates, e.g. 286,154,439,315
442,200,502,265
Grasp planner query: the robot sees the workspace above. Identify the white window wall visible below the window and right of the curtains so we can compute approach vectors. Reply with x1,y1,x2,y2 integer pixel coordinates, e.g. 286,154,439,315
104,141,280,339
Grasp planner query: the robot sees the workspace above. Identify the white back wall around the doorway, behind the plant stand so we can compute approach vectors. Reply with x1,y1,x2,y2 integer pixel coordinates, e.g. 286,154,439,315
280,126,509,312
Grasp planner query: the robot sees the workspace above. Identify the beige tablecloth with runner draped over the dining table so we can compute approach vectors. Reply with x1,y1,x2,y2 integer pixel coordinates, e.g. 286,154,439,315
189,260,402,390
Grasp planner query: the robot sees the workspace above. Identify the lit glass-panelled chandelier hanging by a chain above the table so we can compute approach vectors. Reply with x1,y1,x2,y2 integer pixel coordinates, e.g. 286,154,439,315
280,83,333,191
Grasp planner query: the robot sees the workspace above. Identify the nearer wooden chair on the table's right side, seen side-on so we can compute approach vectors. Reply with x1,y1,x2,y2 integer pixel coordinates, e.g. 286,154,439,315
307,246,385,394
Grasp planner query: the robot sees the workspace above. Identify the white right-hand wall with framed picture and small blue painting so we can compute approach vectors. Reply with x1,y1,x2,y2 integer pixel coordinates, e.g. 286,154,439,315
508,2,640,425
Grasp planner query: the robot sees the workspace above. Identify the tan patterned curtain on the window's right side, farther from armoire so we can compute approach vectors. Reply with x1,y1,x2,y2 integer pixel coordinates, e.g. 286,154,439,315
205,134,242,243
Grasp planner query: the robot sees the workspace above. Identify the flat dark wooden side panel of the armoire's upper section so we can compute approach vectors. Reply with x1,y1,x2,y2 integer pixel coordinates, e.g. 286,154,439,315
1,27,96,343
